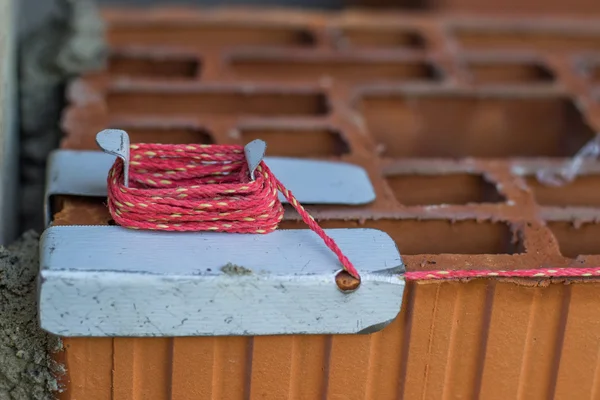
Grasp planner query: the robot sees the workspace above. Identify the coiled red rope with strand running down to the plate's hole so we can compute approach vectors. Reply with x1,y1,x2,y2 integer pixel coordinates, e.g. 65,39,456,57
107,143,360,281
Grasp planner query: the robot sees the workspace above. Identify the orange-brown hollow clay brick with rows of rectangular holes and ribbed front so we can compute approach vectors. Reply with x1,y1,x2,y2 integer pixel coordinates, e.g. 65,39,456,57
54,6,600,400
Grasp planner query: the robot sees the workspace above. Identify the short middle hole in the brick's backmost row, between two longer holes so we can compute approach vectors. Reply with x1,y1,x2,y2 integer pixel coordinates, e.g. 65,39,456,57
340,27,426,50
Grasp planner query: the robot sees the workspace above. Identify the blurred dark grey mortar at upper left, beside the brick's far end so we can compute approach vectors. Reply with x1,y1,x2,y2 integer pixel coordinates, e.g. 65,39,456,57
19,0,107,232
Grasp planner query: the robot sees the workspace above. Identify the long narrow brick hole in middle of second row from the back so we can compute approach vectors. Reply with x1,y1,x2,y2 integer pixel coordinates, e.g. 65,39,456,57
231,58,441,82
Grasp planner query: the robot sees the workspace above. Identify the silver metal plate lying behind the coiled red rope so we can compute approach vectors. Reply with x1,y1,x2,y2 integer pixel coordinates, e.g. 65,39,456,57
44,150,375,226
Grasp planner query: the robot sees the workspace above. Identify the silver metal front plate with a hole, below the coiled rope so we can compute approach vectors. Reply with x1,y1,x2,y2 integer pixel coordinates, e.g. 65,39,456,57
38,226,404,337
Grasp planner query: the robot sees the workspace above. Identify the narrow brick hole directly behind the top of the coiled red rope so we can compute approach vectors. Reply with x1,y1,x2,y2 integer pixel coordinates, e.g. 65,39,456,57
117,127,215,144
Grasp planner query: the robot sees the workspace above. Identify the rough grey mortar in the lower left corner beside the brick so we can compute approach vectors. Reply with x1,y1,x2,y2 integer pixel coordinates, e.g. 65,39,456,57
0,231,64,400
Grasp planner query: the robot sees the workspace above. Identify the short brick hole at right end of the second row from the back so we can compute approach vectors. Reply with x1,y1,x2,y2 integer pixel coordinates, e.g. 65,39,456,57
469,63,554,84
